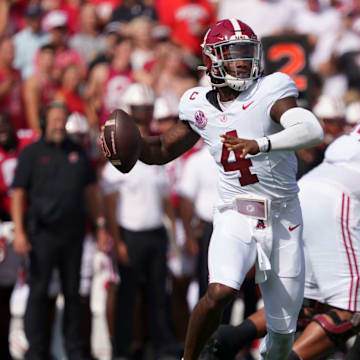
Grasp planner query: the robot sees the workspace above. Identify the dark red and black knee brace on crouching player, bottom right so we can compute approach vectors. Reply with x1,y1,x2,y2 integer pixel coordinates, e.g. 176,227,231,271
313,311,360,345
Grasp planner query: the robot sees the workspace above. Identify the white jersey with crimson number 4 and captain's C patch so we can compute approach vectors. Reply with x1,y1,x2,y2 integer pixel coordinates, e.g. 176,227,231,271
179,72,298,203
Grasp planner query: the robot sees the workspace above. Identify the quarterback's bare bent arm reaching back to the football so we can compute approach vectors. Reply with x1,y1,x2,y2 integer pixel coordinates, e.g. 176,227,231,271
140,121,199,165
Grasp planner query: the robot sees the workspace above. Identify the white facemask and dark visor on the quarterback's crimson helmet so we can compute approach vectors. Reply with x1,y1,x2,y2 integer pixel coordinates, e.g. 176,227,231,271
203,39,262,91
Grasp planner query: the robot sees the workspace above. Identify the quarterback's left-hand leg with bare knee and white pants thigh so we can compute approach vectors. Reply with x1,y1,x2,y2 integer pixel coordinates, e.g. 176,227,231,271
184,210,256,360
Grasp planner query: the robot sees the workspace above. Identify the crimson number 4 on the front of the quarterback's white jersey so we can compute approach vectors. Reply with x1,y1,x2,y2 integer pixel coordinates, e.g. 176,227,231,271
221,130,259,186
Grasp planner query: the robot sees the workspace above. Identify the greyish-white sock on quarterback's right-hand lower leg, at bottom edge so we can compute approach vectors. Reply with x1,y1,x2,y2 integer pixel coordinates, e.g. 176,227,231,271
259,329,294,360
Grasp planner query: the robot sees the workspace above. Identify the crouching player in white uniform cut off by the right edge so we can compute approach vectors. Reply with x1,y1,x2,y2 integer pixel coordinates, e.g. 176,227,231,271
201,121,360,360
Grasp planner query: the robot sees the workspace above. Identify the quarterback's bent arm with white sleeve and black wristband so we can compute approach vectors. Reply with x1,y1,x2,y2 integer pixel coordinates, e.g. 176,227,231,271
222,97,324,158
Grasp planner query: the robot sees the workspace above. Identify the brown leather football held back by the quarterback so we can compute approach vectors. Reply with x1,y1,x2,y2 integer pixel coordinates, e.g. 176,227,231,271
102,109,141,173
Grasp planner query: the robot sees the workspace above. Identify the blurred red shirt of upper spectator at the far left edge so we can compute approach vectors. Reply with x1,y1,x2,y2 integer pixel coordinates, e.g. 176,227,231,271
0,69,27,130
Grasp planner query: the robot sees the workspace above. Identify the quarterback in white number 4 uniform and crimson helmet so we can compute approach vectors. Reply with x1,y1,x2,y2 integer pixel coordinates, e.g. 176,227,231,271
103,19,323,360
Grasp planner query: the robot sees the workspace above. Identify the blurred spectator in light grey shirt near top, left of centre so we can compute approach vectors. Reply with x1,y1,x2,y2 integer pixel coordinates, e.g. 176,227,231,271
69,3,106,64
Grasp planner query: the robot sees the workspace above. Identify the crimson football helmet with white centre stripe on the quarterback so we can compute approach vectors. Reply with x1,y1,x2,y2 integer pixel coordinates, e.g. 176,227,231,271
200,19,262,91
